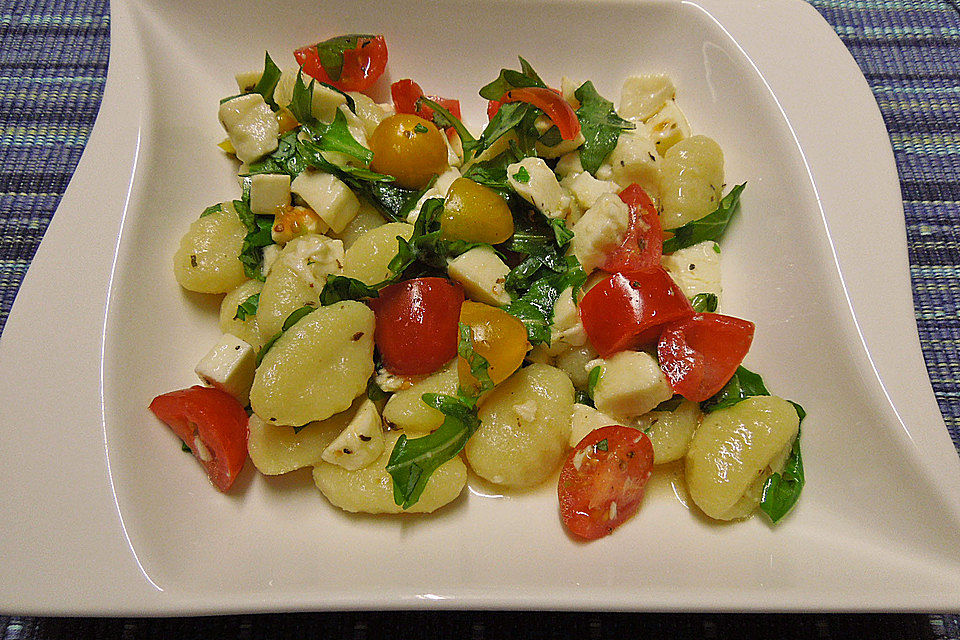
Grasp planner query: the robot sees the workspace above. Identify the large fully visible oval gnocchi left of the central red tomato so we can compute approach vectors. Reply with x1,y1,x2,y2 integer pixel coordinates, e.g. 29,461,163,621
250,300,374,425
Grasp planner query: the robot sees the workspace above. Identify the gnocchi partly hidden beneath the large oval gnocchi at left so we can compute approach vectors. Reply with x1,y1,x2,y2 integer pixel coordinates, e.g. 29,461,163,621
247,397,366,476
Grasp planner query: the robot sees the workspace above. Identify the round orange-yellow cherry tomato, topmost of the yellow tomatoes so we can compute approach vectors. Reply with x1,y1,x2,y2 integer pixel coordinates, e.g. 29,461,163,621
368,113,447,189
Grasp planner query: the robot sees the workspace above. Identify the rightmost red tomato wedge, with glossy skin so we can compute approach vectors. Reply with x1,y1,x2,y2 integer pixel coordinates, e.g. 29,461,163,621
657,313,754,402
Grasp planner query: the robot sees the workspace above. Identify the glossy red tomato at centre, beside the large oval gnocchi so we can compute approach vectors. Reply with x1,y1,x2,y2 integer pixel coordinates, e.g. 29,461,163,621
368,278,464,375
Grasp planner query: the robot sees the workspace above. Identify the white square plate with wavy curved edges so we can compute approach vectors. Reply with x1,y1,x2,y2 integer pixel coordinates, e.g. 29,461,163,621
0,0,960,614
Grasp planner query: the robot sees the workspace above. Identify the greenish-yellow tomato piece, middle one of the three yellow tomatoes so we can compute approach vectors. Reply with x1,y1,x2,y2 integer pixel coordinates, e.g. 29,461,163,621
440,178,513,244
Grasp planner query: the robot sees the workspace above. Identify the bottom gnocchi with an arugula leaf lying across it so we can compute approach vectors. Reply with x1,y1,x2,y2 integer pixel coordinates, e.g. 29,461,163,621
313,431,467,513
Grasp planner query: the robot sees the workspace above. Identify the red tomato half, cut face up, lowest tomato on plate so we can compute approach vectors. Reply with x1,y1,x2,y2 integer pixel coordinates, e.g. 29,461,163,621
557,425,653,540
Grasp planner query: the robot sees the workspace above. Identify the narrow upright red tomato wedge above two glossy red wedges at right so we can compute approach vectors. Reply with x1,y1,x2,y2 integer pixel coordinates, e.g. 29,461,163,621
600,184,663,274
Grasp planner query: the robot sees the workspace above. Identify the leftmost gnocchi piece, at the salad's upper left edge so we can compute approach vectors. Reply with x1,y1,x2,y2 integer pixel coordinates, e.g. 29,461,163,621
173,205,247,293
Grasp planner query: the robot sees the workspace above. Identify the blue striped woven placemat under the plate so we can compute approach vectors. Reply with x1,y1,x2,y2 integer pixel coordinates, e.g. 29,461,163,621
0,0,960,640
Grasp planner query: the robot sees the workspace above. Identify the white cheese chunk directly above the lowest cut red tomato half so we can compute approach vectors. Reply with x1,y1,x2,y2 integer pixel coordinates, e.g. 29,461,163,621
593,351,673,418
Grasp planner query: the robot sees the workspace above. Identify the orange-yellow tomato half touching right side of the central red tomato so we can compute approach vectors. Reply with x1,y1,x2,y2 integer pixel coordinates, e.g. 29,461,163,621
457,300,530,389
